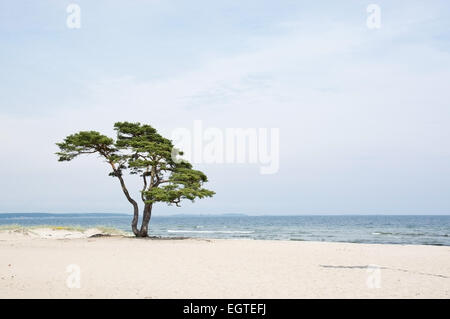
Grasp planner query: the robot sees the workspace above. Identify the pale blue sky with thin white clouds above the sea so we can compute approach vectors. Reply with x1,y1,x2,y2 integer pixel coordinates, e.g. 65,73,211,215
0,0,450,215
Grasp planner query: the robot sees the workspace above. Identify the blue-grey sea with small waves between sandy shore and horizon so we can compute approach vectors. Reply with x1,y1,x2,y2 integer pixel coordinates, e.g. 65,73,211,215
0,213,450,246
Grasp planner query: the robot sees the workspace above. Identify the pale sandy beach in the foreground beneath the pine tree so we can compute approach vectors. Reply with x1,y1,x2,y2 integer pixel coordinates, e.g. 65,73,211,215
0,228,450,298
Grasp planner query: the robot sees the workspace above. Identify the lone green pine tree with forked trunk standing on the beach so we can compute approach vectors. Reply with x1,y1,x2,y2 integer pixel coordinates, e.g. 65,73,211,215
56,122,215,237
